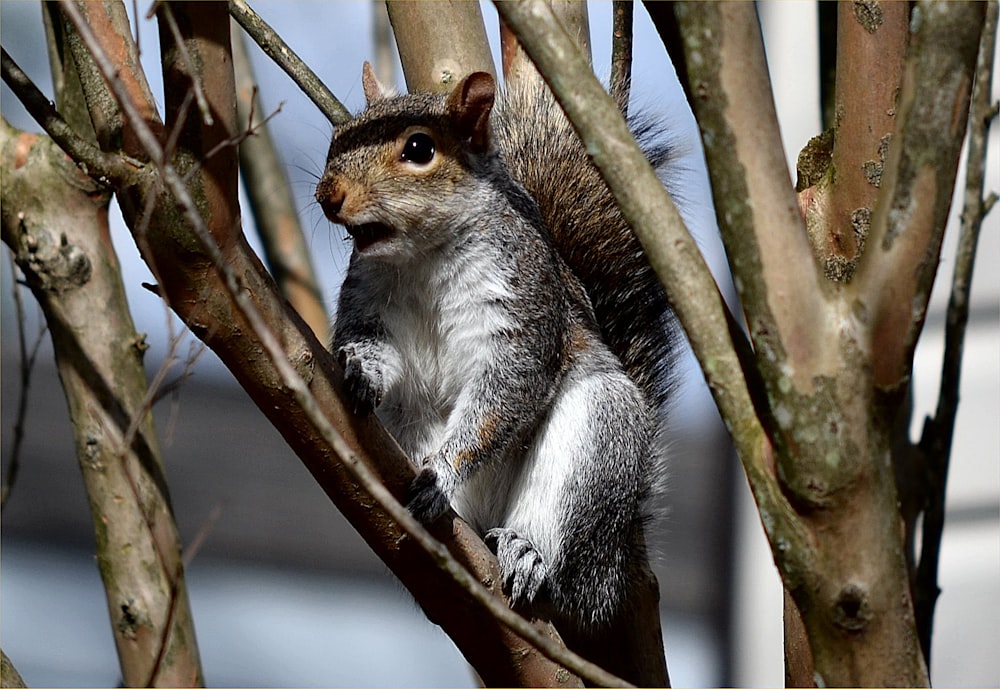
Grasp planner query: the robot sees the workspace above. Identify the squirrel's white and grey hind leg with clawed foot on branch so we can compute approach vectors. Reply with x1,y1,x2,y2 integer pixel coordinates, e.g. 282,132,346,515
488,366,649,629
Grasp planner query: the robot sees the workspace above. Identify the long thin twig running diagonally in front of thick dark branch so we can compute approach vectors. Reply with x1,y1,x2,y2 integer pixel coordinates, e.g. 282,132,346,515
62,0,631,686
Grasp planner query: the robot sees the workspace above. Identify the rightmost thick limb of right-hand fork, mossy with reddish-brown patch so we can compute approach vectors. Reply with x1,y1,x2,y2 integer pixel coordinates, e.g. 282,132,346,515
853,2,985,391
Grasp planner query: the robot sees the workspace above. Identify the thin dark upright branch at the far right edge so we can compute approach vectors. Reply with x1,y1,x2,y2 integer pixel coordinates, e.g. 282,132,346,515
914,2,997,665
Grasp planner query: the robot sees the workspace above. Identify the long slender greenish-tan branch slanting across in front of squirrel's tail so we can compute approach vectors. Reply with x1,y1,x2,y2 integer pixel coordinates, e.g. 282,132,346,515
497,2,812,582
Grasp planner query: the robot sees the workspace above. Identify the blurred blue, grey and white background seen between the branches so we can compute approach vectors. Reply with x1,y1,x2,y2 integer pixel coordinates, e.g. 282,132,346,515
0,0,1000,687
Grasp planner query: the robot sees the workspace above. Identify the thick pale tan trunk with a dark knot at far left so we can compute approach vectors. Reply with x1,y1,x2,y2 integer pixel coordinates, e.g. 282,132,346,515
0,118,202,686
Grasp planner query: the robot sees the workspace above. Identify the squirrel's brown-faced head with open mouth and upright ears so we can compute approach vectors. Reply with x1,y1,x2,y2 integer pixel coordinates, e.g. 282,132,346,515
316,62,495,260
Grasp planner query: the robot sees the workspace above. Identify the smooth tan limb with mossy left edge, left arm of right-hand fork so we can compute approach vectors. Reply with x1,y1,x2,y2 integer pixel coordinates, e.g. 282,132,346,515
675,2,836,392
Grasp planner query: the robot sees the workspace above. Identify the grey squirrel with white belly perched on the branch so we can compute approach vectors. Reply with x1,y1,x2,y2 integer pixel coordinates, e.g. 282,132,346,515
316,63,677,633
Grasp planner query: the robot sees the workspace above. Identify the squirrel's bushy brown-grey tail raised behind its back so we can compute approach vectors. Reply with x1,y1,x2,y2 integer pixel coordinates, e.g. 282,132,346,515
494,80,680,413
